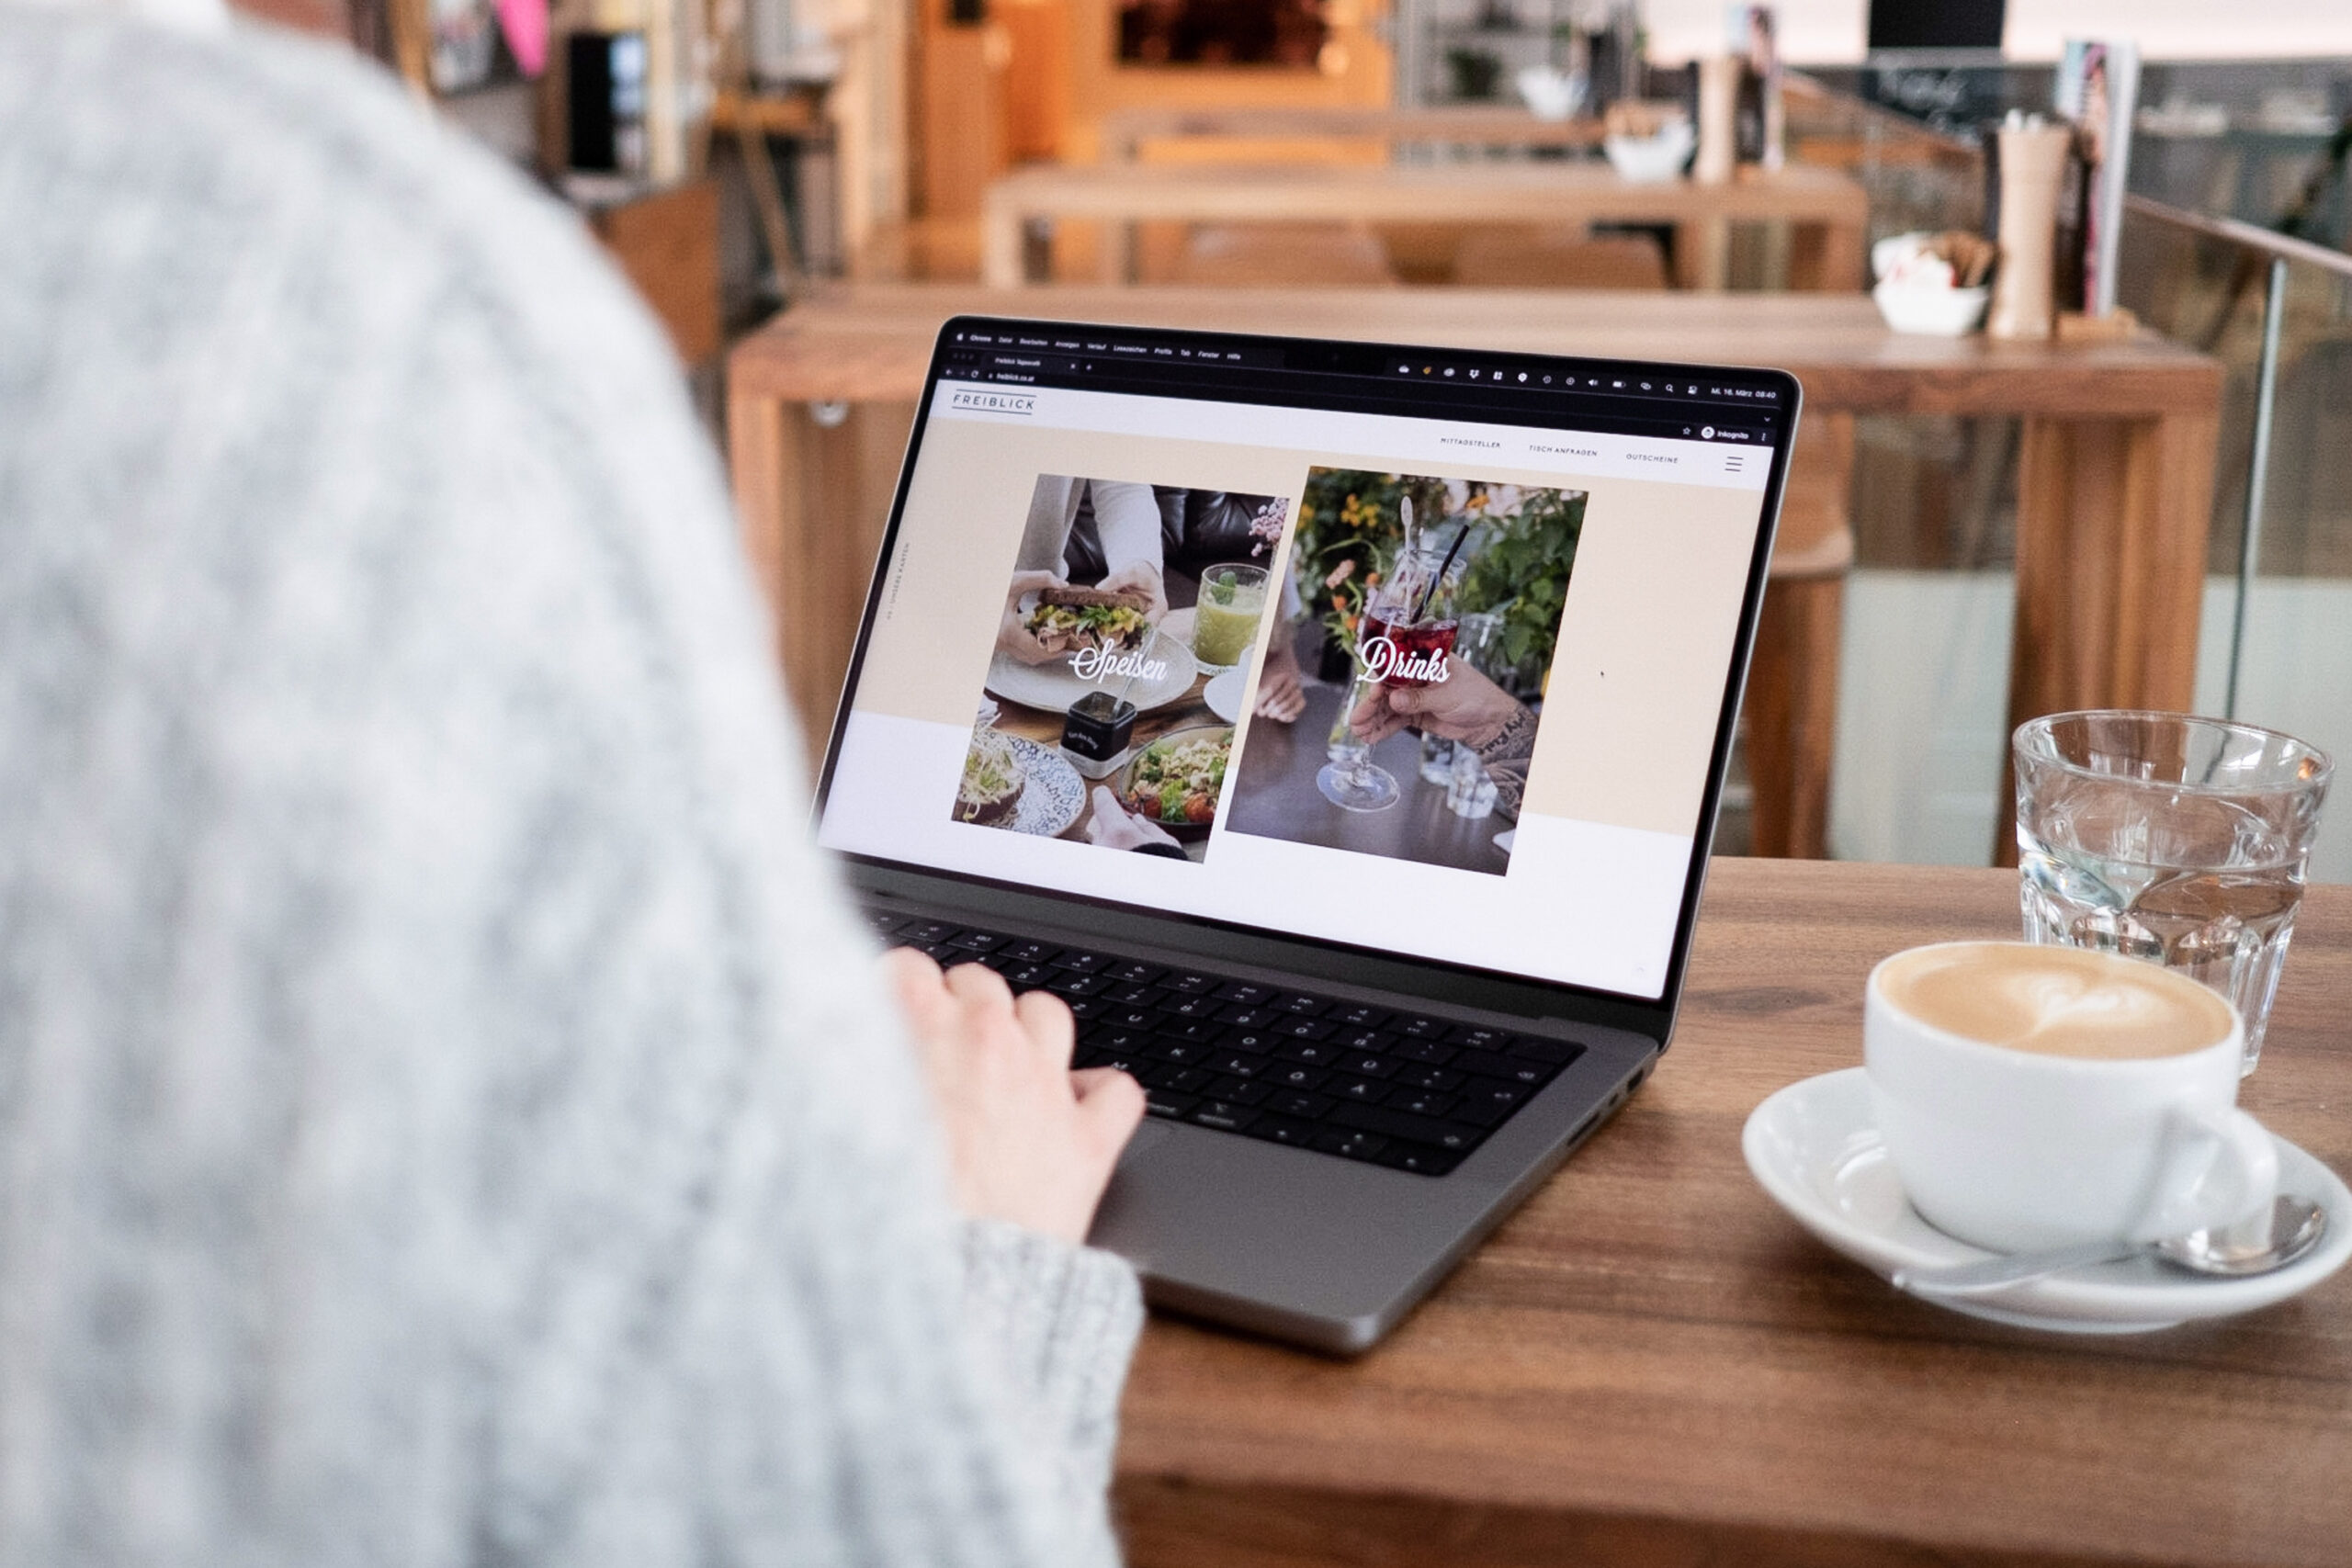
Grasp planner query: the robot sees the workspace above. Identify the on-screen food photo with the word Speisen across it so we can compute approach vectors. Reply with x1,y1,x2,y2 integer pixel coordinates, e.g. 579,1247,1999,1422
953,475,1291,863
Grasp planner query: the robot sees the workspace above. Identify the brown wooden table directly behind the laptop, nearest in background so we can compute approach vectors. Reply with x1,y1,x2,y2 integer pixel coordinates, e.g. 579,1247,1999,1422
727,285,2221,853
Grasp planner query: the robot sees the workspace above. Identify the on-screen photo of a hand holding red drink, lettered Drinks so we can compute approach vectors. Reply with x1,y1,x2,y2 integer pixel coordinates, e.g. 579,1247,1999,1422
1226,468,1585,874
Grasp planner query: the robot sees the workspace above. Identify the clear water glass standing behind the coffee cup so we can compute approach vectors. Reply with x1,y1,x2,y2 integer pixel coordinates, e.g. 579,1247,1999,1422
2011,710,2334,1072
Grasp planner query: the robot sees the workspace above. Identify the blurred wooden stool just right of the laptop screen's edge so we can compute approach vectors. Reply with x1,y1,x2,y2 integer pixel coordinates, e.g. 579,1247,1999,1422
1746,413,1853,861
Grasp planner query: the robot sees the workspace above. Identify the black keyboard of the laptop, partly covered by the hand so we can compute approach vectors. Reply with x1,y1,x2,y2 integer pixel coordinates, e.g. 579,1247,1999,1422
870,912,1583,1176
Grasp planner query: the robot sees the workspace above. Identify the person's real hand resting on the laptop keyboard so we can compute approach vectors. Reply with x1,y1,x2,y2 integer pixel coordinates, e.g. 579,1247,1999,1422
882,947,1143,1246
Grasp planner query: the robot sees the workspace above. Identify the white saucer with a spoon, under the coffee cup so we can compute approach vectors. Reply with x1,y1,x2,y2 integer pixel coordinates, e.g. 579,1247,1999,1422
1740,1067,2352,1333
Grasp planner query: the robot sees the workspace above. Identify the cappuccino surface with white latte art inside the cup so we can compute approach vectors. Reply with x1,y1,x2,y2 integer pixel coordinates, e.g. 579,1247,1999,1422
1877,942,2232,1060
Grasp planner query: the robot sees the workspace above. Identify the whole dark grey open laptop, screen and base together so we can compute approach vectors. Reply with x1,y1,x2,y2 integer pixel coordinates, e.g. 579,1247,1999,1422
816,317,1799,1354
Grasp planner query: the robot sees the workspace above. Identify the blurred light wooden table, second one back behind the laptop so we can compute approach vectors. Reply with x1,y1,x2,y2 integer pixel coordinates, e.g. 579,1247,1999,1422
981,163,1870,291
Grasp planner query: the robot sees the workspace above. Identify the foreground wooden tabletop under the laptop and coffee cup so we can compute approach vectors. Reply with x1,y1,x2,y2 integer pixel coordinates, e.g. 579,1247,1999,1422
1117,861,2352,1568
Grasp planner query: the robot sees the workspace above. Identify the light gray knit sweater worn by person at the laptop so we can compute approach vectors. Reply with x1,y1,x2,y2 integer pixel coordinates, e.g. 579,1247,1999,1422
0,7,1141,1568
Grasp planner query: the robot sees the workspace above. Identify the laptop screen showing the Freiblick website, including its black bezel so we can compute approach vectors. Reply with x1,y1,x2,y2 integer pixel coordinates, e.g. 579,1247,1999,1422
819,317,1797,999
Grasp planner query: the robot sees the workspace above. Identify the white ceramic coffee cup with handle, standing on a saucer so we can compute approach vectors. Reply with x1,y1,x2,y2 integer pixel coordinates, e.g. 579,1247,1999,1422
1863,942,2279,1253
